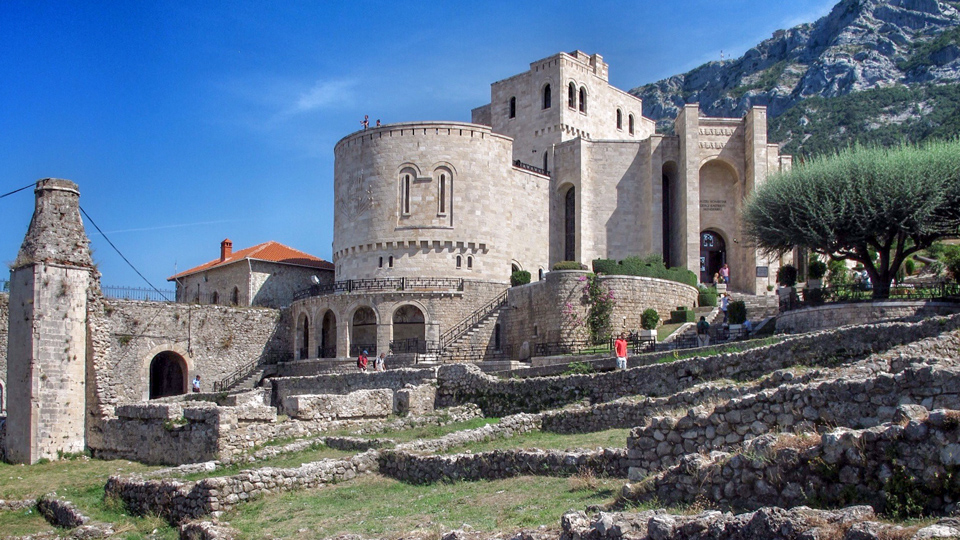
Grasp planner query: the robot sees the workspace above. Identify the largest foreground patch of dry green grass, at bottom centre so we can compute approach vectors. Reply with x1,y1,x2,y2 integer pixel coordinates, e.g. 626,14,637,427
223,475,623,539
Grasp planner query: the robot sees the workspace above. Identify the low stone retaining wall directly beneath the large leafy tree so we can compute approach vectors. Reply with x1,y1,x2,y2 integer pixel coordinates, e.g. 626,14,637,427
776,300,960,334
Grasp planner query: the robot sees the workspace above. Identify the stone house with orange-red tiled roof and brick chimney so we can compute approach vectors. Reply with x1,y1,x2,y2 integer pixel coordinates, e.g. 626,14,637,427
167,238,334,308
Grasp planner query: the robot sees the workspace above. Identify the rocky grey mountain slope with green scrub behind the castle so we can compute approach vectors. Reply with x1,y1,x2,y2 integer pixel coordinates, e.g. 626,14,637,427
630,0,960,154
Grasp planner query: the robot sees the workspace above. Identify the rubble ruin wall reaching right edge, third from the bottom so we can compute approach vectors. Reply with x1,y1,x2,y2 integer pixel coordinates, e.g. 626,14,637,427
627,367,960,478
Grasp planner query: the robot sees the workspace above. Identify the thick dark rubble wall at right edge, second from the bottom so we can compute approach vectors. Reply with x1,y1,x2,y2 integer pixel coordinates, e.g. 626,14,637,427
622,405,960,515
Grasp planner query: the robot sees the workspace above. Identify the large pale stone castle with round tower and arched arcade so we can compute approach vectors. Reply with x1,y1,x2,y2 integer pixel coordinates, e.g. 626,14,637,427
293,51,791,358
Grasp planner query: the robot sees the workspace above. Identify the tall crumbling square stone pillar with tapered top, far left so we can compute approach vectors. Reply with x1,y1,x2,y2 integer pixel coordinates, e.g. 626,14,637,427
6,178,95,463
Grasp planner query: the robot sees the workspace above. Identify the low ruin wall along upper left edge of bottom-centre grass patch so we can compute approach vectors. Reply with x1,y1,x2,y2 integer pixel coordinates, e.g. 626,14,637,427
105,451,377,523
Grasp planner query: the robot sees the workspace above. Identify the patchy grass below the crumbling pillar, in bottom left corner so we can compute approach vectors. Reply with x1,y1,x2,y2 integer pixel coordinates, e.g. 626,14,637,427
0,458,178,539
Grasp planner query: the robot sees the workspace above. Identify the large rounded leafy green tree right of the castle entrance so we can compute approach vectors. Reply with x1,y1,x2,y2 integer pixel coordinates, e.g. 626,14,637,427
744,140,960,298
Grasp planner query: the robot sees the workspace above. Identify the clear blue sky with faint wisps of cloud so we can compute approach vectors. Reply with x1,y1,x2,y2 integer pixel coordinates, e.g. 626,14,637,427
0,0,833,289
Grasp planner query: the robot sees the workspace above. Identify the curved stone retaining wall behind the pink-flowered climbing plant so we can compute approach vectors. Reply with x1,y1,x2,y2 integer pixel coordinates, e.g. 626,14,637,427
500,270,698,348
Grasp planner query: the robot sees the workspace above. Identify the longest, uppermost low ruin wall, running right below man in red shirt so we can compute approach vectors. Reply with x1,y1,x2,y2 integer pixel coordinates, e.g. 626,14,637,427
437,315,960,416
